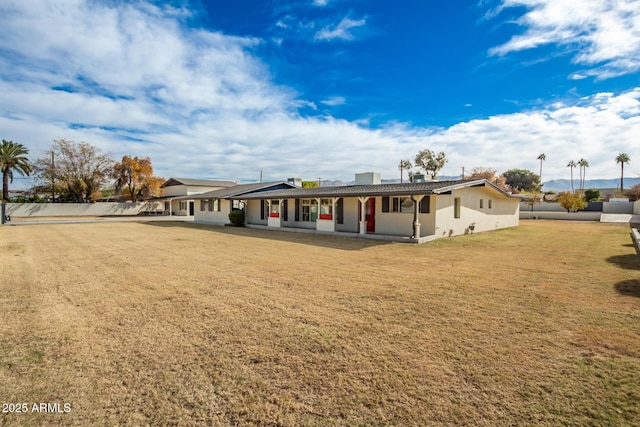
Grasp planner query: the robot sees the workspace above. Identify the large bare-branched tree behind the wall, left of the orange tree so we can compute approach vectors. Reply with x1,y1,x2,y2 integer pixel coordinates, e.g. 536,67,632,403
34,139,113,203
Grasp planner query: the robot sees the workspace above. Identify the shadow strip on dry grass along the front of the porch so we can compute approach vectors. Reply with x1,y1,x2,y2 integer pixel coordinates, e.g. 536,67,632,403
141,221,390,251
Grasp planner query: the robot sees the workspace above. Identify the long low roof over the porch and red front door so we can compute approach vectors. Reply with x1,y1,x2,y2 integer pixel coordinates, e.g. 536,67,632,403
228,179,511,200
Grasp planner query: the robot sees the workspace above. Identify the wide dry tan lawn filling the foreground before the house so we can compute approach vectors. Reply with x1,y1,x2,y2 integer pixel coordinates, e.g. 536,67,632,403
0,221,640,426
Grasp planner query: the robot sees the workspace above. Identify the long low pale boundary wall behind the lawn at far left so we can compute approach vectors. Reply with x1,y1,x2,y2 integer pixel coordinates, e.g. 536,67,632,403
6,202,159,218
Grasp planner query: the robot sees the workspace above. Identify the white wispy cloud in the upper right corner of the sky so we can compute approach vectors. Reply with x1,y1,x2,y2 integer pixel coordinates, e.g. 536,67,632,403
490,0,640,79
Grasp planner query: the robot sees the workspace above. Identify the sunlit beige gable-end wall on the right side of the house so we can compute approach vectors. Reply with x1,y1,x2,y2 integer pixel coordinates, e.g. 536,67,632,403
434,187,519,237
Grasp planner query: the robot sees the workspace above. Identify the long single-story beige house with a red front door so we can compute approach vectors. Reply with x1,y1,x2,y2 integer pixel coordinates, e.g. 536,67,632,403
185,174,519,243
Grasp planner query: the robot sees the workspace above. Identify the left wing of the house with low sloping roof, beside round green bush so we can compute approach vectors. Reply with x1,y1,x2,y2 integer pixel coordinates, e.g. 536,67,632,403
182,181,298,225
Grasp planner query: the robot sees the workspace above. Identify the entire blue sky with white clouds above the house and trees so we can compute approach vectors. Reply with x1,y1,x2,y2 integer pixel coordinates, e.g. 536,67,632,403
0,0,640,187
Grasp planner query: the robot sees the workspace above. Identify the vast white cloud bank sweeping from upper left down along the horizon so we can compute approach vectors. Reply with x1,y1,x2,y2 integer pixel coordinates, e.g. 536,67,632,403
0,0,640,189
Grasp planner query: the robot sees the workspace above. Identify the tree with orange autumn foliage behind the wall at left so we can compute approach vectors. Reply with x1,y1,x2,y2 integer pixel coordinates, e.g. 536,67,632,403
113,156,164,202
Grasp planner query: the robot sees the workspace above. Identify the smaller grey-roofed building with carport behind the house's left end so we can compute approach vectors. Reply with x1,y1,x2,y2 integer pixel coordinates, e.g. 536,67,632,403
154,178,237,216
